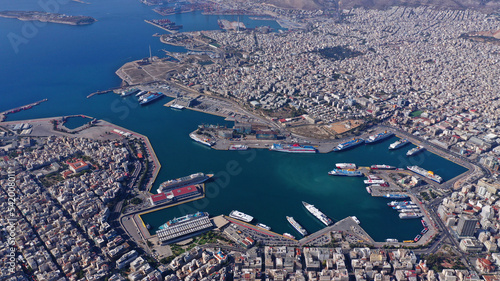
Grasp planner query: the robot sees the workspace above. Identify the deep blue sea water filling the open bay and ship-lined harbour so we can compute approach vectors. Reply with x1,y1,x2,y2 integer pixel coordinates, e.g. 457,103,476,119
0,0,465,240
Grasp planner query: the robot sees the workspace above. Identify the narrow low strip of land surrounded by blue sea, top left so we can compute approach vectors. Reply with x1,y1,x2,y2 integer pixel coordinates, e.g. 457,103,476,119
0,11,97,25
